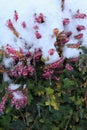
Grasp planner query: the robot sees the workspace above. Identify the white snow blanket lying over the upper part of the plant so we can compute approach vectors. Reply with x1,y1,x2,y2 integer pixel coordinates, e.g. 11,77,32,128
0,0,87,65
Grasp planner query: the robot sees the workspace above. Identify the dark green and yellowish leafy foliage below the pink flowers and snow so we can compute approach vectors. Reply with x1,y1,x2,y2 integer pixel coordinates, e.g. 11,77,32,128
0,46,87,130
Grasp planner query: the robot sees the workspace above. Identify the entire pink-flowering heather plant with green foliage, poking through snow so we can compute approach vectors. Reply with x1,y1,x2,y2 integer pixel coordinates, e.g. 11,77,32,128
0,11,87,130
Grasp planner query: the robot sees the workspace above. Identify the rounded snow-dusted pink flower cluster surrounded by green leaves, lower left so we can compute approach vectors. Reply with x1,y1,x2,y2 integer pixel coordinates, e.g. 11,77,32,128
11,91,27,109
